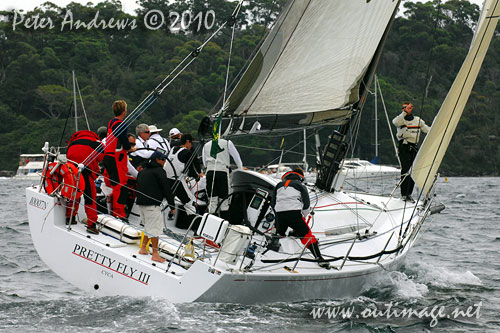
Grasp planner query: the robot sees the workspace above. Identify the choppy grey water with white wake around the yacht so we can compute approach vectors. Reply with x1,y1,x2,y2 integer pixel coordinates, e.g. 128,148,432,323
0,178,500,332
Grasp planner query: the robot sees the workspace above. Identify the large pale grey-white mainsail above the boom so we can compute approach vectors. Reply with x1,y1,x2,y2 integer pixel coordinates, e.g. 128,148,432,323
223,0,400,132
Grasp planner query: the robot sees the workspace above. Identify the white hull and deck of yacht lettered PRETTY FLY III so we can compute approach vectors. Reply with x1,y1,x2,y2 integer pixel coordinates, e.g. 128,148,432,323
26,172,432,303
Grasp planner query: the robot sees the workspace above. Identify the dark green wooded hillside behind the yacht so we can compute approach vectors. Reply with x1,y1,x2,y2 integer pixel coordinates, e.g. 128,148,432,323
0,0,500,177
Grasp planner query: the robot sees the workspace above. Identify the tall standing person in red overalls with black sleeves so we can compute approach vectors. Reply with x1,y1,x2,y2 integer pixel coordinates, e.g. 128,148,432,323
104,100,135,220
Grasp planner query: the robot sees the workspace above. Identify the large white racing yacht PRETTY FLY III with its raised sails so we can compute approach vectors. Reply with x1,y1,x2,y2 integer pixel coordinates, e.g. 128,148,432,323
26,0,500,303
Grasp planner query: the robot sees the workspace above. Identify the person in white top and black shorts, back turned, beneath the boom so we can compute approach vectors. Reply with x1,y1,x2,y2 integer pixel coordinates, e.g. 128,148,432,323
202,139,243,213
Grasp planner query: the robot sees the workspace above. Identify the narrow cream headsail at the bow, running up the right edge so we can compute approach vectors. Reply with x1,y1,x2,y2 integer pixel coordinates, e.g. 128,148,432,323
411,0,500,195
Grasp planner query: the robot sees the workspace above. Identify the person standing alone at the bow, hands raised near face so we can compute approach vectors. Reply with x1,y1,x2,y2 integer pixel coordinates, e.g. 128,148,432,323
392,102,430,202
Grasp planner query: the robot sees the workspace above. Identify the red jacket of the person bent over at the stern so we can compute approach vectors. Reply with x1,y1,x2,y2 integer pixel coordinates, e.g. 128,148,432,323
67,130,104,178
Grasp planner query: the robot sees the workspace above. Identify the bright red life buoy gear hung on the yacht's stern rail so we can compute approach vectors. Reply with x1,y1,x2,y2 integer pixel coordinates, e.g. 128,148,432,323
43,162,85,199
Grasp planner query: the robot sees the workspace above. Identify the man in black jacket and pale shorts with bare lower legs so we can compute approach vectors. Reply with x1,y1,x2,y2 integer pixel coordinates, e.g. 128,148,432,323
136,151,175,262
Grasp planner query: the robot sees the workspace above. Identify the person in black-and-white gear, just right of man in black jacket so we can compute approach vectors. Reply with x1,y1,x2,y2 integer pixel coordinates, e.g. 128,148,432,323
163,134,201,229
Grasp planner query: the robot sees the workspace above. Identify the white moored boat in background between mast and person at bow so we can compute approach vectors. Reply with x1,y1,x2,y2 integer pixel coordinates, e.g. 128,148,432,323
341,158,401,180
